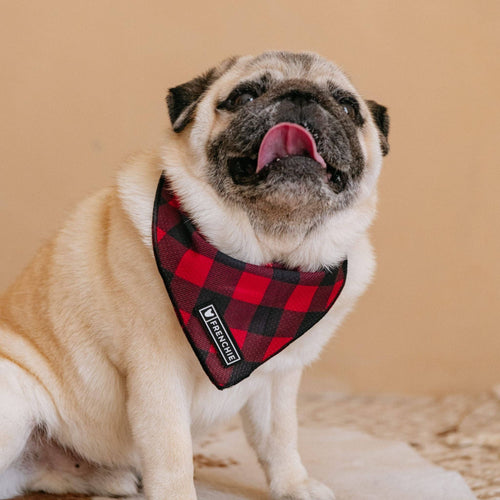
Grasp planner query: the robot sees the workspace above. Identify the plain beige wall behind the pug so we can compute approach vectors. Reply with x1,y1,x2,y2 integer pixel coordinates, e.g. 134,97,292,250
0,0,500,393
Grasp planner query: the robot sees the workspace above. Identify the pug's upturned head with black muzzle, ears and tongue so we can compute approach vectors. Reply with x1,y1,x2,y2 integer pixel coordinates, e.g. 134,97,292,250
167,52,389,244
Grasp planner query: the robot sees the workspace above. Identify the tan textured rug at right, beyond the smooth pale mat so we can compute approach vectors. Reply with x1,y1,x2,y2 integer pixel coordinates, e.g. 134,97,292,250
299,386,500,500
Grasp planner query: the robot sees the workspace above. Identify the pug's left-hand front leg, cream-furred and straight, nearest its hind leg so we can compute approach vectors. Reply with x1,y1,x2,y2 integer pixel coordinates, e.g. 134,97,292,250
128,356,196,500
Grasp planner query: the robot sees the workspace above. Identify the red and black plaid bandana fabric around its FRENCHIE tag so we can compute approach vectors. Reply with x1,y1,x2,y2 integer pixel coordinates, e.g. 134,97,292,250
153,176,347,389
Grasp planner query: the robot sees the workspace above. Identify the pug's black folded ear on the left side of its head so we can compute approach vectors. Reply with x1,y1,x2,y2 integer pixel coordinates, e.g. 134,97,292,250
167,68,216,132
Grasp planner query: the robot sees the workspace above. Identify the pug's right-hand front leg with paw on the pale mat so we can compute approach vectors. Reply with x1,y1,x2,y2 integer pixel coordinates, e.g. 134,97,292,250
242,370,334,500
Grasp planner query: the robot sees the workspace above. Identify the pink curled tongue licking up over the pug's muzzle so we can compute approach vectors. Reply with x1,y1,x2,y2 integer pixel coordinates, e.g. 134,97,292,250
257,122,326,172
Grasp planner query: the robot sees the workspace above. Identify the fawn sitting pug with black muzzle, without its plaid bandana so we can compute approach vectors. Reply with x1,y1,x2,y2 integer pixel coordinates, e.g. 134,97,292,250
0,52,389,500
